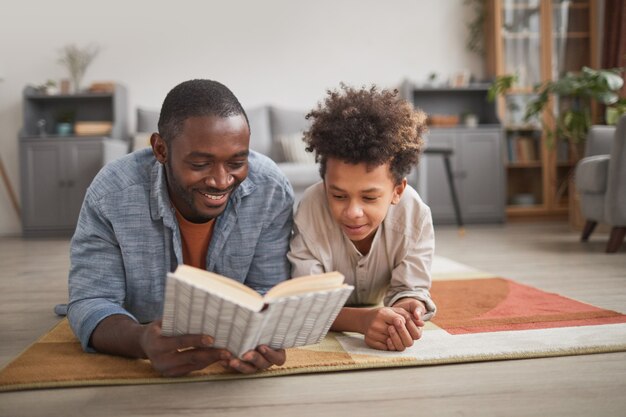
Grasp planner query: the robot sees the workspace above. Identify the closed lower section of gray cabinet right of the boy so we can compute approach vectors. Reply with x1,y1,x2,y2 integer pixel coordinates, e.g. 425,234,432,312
418,126,505,224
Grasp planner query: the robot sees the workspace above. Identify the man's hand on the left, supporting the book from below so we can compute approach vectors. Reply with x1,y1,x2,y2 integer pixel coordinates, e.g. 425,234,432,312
139,320,232,376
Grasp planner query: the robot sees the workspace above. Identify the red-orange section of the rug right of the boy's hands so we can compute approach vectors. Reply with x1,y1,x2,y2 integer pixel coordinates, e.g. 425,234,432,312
432,278,626,334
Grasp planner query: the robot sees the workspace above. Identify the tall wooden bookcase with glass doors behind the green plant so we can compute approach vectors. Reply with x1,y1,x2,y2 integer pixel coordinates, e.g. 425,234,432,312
486,0,597,219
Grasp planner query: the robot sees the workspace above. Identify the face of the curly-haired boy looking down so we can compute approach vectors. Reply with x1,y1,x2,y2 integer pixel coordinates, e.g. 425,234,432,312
324,158,406,250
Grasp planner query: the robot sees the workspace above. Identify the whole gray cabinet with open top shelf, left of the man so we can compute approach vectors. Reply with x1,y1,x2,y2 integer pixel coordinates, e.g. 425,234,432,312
19,86,127,236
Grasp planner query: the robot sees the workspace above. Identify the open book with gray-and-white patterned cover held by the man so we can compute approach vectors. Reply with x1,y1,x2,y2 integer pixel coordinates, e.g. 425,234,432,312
162,265,354,356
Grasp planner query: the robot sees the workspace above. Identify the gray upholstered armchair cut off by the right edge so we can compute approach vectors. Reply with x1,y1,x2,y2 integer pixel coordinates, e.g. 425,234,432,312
575,116,626,253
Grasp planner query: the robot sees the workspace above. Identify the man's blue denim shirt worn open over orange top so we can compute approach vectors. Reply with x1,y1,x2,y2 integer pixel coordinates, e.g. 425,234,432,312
68,149,293,350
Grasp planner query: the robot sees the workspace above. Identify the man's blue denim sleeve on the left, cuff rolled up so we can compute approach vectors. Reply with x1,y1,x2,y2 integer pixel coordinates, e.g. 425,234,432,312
68,195,136,352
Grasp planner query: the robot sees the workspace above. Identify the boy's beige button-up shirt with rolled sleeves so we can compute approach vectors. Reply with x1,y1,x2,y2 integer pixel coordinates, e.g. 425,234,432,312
287,182,436,319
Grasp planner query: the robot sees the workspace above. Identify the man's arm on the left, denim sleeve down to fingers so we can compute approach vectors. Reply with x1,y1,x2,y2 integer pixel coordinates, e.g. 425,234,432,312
68,197,230,376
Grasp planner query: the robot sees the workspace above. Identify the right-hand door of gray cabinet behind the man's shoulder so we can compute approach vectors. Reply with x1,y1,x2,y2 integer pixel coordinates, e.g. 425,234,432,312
63,140,102,224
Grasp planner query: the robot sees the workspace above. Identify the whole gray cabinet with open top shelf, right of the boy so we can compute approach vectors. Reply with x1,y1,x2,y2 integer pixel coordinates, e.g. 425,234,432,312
400,81,505,224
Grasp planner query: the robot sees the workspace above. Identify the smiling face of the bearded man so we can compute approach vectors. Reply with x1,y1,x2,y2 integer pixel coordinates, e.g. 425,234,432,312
152,115,250,223
